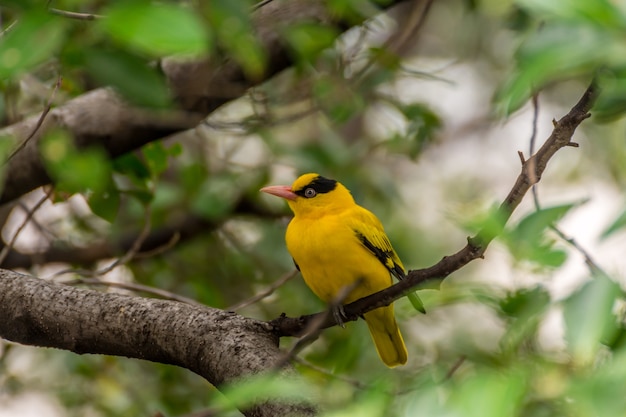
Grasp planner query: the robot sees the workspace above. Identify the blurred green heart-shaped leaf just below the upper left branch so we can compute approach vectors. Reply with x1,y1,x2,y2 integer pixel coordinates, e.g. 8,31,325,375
41,131,112,193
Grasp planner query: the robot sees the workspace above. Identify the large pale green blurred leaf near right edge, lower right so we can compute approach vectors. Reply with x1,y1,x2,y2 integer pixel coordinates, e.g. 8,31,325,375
563,275,621,363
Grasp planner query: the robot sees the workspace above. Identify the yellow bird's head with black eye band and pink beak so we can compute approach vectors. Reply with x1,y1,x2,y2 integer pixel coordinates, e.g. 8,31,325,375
261,173,355,217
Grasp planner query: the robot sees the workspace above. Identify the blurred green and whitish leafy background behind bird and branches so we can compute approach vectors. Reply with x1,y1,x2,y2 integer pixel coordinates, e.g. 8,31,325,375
0,0,626,417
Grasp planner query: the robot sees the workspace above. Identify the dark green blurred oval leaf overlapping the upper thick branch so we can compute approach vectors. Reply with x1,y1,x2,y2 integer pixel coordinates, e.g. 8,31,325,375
84,49,170,108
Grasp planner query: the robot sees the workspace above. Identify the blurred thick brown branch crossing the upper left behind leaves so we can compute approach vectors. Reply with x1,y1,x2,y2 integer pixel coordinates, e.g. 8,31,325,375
0,0,402,204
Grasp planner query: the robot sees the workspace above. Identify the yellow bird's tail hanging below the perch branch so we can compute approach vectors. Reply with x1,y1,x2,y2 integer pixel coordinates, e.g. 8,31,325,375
364,306,407,368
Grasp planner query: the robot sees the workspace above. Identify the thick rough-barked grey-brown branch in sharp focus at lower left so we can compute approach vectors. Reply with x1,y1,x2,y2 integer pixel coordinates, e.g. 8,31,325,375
0,270,316,417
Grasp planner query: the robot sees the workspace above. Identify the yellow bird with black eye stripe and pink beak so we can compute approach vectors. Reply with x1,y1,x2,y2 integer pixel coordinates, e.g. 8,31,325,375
261,173,424,367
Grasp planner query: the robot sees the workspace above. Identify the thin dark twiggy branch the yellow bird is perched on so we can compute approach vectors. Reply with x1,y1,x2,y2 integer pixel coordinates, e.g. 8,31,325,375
269,82,598,337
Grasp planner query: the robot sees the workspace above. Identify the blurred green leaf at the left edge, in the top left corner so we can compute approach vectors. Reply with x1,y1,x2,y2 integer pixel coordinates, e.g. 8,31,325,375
0,9,65,78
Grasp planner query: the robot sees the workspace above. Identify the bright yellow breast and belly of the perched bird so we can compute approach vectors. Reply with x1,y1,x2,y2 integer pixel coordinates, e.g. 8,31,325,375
286,210,392,303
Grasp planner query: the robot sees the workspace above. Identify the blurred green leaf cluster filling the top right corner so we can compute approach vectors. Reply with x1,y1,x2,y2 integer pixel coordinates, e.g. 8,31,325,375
497,0,626,115
